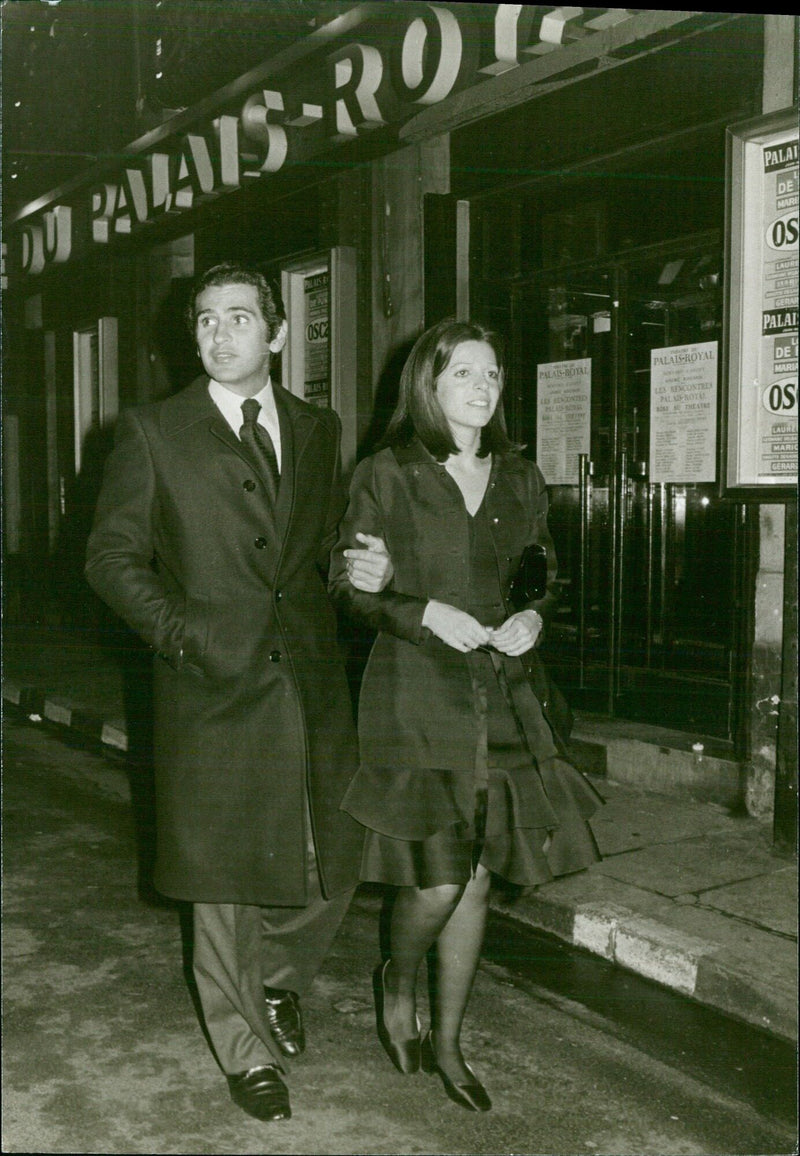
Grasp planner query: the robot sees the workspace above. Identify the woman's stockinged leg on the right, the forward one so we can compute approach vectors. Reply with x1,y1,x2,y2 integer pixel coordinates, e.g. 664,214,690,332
431,865,490,1084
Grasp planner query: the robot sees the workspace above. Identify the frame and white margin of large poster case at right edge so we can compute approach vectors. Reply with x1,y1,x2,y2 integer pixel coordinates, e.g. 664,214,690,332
719,105,798,502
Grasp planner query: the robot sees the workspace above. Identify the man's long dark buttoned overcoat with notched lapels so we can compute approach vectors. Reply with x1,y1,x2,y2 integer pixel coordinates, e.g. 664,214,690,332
87,377,363,905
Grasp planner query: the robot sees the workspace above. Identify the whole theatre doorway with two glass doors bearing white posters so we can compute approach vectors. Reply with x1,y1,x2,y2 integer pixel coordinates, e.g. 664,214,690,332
506,234,745,743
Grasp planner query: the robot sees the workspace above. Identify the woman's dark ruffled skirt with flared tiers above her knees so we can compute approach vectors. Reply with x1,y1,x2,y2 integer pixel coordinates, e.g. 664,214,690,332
342,651,603,888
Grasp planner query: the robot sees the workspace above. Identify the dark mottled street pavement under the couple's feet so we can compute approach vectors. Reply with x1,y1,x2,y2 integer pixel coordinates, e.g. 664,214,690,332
3,720,795,1156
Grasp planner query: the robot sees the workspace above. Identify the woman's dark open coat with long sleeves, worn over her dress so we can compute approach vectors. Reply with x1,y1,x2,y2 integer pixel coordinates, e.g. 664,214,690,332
331,439,564,838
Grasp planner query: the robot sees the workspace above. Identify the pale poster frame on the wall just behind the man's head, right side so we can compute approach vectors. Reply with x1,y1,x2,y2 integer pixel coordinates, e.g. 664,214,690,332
281,245,357,470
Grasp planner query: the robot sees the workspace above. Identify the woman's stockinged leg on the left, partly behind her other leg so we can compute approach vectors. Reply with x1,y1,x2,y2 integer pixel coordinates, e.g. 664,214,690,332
384,883,464,1040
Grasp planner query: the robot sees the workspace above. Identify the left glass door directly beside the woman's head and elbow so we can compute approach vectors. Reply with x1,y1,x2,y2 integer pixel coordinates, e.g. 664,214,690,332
506,267,617,711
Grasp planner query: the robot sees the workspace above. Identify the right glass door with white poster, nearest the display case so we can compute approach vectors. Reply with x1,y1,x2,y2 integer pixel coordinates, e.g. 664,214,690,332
614,242,740,738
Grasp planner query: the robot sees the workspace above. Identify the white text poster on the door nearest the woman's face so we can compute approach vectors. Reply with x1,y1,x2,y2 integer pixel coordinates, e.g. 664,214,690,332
536,357,592,486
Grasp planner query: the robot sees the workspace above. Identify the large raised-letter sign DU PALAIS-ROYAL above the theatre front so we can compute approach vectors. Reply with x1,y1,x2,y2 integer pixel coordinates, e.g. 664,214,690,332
8,3,635,274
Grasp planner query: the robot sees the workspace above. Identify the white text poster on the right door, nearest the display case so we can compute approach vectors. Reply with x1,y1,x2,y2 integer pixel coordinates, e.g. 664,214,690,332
650,341,718,483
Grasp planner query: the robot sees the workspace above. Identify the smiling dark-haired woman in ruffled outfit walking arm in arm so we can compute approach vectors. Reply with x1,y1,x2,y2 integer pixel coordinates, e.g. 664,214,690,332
331,320,601,1111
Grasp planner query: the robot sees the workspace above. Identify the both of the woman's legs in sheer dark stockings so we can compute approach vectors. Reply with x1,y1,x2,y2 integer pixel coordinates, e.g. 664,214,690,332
384,865,489,1083
